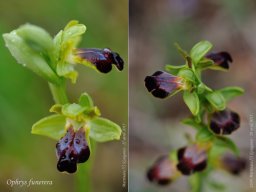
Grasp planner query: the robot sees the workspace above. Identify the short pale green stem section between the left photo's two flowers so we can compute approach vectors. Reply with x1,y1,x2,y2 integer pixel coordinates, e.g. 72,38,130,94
49,81,68,104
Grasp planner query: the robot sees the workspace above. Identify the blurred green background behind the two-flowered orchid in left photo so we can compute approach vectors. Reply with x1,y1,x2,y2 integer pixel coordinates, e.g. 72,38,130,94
0,0,128,192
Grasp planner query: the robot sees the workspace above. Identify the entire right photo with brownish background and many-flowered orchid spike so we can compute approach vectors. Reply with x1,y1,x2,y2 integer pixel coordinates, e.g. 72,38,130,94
129,0,256,192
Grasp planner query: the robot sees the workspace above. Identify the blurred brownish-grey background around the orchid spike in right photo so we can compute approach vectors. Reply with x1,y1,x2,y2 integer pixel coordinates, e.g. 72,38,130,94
129,0,256,192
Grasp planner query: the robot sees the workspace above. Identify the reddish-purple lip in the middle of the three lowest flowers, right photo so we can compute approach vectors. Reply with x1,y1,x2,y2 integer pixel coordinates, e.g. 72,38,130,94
177,145,207,175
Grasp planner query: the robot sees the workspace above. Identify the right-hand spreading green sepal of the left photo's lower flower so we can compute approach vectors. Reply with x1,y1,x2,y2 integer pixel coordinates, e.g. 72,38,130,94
88,117,122,142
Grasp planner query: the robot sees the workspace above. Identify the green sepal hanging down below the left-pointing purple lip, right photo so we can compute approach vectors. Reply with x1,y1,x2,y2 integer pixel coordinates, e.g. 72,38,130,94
183,91,200,115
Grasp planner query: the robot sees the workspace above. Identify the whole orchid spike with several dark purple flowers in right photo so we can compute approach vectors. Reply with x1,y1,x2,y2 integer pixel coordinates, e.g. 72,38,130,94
145,41,245,192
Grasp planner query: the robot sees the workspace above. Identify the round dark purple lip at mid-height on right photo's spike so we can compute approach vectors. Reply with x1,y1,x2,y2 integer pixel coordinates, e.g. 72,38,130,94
210,109,240,135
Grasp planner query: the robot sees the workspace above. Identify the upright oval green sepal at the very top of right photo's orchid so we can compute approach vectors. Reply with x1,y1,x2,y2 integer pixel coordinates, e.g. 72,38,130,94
190,41,212,65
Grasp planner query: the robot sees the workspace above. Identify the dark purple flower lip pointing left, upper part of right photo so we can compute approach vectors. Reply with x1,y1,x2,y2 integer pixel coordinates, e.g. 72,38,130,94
145,71,182,98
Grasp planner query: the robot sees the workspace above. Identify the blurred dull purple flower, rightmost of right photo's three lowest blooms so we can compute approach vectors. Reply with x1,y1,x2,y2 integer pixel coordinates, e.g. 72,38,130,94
221,154,246,175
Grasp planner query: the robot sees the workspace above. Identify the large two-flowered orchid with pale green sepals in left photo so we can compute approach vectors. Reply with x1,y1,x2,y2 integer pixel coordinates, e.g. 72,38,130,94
3,20,124,173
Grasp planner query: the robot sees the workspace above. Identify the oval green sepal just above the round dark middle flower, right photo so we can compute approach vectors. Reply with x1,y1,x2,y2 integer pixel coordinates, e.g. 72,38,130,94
206,91,226,111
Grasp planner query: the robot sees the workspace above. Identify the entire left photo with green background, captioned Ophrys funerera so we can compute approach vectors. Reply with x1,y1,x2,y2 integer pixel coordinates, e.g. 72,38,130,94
0,0,128,192
